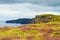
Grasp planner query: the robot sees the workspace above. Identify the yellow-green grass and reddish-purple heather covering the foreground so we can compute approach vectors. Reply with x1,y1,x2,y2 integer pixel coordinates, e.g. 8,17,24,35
0,14,60,40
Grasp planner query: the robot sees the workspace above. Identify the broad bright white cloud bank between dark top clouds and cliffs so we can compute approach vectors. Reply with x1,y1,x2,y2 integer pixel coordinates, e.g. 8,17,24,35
0,3,60,20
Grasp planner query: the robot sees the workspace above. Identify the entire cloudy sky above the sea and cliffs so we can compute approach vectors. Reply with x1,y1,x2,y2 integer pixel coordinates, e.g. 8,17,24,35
0,0,60,21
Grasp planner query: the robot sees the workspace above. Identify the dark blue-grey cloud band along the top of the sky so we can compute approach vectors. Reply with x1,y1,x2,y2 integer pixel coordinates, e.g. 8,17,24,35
0,0,60,6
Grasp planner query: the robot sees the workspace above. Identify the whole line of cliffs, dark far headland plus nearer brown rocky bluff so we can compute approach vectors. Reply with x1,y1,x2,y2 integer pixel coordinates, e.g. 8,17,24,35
6,14,60,24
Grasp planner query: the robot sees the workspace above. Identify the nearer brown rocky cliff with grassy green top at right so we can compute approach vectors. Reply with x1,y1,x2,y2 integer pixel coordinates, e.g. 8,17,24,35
34,14,60,24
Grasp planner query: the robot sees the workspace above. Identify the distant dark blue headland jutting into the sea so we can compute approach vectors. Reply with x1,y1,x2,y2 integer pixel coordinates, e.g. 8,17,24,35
6,18,32,24
